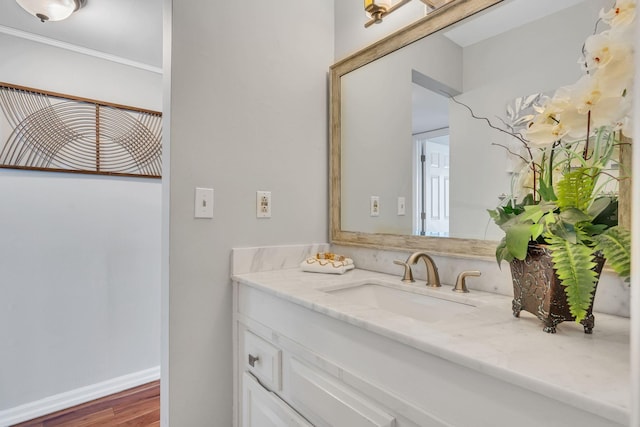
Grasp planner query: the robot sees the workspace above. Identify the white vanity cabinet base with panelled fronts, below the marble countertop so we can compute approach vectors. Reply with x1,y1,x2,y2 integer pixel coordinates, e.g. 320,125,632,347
233,282,625,427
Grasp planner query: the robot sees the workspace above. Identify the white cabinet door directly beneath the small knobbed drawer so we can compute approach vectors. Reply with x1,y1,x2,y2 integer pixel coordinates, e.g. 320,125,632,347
242,372,313,427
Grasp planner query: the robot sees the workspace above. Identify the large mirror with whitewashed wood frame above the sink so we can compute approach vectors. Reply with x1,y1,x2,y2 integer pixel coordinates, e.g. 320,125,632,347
330,0,630,258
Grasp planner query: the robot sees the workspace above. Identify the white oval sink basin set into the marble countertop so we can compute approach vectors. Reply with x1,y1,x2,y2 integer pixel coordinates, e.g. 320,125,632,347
324,283,476,322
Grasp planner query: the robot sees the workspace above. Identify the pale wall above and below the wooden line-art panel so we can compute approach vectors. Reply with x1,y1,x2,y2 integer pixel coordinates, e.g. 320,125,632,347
0,35,162,424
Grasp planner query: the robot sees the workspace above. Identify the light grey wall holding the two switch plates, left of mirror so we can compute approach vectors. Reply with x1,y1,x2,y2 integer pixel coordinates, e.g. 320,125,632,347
168,0,334,426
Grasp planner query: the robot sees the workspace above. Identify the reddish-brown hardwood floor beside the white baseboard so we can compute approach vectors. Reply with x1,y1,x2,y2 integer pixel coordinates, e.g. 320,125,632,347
13,381,160,427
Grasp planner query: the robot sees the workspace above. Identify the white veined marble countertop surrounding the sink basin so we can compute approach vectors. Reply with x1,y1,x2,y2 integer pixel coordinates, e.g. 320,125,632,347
233,268,630,424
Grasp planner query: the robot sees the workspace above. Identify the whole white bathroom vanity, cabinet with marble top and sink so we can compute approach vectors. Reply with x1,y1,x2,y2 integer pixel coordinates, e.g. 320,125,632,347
233,268,630,427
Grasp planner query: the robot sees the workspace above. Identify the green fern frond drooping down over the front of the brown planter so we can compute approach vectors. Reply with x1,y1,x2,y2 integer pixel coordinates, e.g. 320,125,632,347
547,236,598,322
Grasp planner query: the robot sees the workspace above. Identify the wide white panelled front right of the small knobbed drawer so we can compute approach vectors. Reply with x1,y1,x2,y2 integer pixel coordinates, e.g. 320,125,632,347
287,358,396,427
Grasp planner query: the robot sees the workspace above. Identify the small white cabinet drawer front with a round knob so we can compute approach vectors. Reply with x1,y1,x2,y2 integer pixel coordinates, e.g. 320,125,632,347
242,331,282,391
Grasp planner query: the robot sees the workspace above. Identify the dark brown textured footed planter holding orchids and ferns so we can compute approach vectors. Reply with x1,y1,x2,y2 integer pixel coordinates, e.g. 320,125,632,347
510,244,605,334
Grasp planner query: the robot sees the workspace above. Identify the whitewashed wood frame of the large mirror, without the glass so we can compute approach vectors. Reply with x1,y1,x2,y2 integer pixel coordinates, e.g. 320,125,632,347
329,0,631,259
